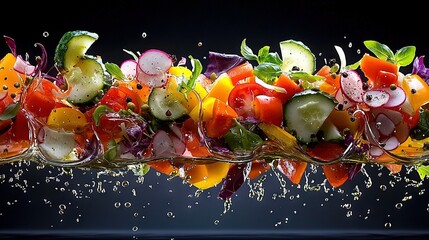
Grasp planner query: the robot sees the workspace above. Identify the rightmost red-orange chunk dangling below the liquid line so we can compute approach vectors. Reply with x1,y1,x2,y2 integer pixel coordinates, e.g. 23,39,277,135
322,163,351,187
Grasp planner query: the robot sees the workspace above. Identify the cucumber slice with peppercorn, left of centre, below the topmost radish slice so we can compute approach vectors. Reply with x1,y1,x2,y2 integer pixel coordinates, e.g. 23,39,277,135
148,87,188,121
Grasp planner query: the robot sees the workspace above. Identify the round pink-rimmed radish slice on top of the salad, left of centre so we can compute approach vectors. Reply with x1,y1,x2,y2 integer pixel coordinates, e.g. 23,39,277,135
138,49,173,75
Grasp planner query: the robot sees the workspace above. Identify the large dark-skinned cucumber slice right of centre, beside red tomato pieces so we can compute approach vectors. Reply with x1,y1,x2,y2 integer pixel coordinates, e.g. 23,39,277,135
284,90,336,144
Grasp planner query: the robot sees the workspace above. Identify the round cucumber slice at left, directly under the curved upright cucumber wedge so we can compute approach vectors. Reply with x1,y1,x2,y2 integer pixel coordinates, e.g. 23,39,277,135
64,56,108,104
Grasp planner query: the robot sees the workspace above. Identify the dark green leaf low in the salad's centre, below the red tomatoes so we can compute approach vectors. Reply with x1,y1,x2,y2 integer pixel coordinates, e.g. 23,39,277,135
225,119,263,153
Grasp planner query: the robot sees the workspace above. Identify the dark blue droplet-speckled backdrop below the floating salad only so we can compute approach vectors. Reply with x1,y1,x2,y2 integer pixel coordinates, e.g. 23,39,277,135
0,162,429,239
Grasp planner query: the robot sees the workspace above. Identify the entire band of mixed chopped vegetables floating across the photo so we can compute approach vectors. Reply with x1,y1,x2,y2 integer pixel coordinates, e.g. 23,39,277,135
0,30,429,200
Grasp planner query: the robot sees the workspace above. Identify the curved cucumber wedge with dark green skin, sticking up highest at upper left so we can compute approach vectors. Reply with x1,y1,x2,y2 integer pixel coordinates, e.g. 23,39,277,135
54,30,98,71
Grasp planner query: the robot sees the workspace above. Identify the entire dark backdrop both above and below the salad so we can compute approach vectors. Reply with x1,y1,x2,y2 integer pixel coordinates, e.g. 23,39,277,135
0,0,429,239
